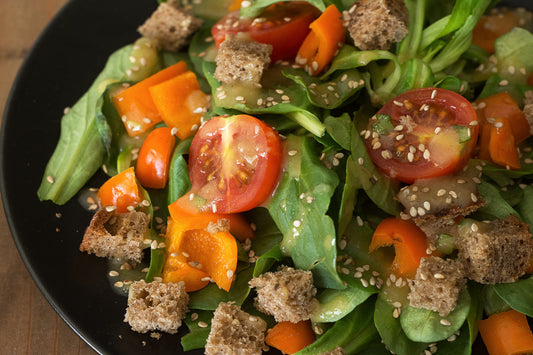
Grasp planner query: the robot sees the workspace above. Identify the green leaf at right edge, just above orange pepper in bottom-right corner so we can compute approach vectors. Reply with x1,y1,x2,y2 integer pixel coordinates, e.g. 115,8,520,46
493,277,533,317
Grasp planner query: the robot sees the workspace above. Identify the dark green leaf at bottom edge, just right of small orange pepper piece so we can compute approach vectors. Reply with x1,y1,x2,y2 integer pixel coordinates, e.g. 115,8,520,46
296,299,378,355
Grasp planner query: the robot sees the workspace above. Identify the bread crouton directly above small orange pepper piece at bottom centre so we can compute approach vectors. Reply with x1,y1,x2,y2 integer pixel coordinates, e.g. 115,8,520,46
248,266,316,323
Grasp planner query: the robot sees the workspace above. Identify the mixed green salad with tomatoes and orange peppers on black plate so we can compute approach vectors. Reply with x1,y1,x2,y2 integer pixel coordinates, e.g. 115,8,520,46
38,0,533,354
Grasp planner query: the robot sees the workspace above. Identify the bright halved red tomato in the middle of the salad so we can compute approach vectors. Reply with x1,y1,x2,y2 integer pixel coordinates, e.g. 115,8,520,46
189,115,282,213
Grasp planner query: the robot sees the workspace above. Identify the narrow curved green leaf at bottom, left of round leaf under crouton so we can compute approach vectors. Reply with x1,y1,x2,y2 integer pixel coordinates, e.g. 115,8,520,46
374,296,428,354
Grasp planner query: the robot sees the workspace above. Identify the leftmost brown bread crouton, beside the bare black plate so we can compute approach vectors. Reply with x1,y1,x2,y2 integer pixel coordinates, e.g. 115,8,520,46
80,208,150,262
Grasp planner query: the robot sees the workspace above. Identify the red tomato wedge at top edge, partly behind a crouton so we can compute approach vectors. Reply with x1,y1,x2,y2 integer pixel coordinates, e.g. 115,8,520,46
211,2,320,63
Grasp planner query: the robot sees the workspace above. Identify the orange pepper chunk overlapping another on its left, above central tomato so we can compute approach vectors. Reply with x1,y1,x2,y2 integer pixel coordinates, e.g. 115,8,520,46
149,71,209,139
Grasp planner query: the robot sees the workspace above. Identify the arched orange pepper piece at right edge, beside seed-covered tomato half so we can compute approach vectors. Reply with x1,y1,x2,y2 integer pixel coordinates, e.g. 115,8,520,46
474,91,531,144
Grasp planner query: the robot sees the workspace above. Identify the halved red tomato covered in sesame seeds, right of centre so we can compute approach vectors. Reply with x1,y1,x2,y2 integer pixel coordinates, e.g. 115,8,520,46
364,88,478,183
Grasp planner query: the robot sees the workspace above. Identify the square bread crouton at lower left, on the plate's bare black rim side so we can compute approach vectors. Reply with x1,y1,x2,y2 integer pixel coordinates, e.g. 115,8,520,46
124,280,189,334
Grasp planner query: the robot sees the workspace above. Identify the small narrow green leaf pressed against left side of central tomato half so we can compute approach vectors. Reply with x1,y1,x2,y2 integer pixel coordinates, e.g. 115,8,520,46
167,137,192,205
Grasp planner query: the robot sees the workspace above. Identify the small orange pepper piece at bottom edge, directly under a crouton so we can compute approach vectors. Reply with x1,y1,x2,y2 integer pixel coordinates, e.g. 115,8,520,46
265,320,315,354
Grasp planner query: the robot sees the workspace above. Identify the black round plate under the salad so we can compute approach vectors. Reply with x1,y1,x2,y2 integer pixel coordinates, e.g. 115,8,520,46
0,0,532,354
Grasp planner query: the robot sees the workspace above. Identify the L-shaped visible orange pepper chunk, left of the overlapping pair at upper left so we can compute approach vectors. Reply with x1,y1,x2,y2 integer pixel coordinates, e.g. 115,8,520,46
113,61,187,137
